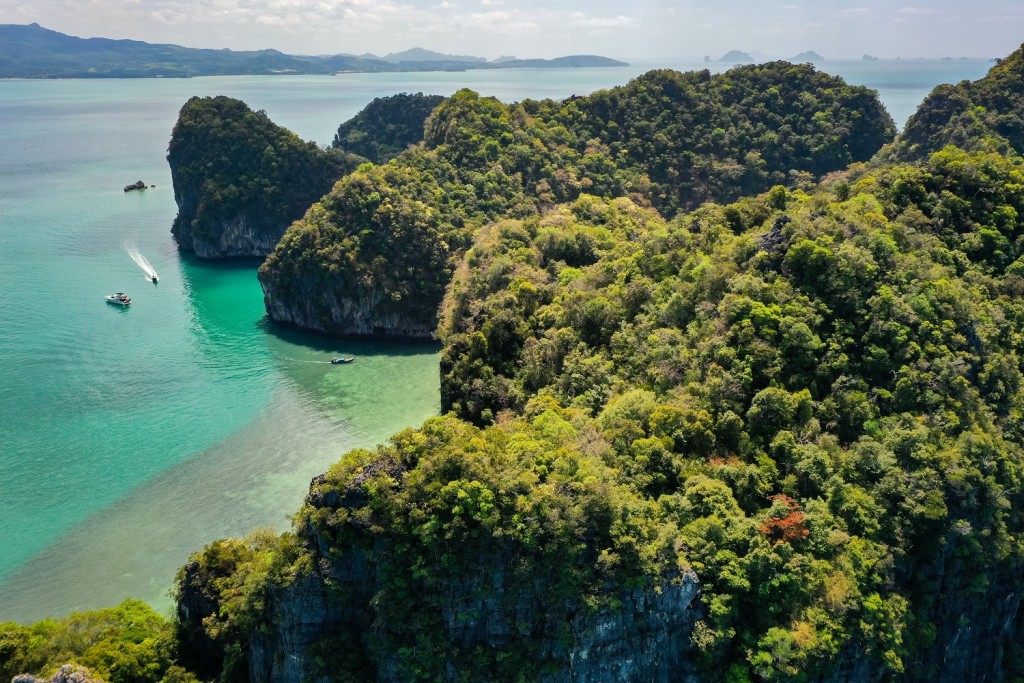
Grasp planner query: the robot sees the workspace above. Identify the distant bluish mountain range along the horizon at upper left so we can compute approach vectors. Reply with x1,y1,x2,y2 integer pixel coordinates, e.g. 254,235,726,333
0,24,628,78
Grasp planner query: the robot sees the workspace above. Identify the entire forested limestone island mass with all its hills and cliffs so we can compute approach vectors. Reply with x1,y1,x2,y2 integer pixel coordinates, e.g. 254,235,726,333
6,46,1024,683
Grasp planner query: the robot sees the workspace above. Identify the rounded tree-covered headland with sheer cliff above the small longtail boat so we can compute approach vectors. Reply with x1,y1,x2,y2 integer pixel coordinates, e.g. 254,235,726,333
259,163,465,339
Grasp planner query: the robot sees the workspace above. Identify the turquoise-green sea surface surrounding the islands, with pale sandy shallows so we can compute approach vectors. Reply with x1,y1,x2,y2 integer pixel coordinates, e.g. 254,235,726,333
0,59,990,622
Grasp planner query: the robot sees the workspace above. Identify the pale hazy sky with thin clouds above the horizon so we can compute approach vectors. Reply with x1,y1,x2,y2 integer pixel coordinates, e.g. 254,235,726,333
0,0,1024,61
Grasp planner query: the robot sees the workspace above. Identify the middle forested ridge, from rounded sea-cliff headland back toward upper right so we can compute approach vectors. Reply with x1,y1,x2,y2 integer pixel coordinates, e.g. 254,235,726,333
260,62,894,336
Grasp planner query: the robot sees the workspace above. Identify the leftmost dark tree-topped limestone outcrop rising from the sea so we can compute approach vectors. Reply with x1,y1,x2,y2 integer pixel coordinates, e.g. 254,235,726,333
167,97,354,259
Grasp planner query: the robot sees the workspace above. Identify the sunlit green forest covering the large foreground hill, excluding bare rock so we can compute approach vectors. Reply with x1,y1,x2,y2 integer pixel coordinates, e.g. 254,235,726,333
200,148,1024,681
